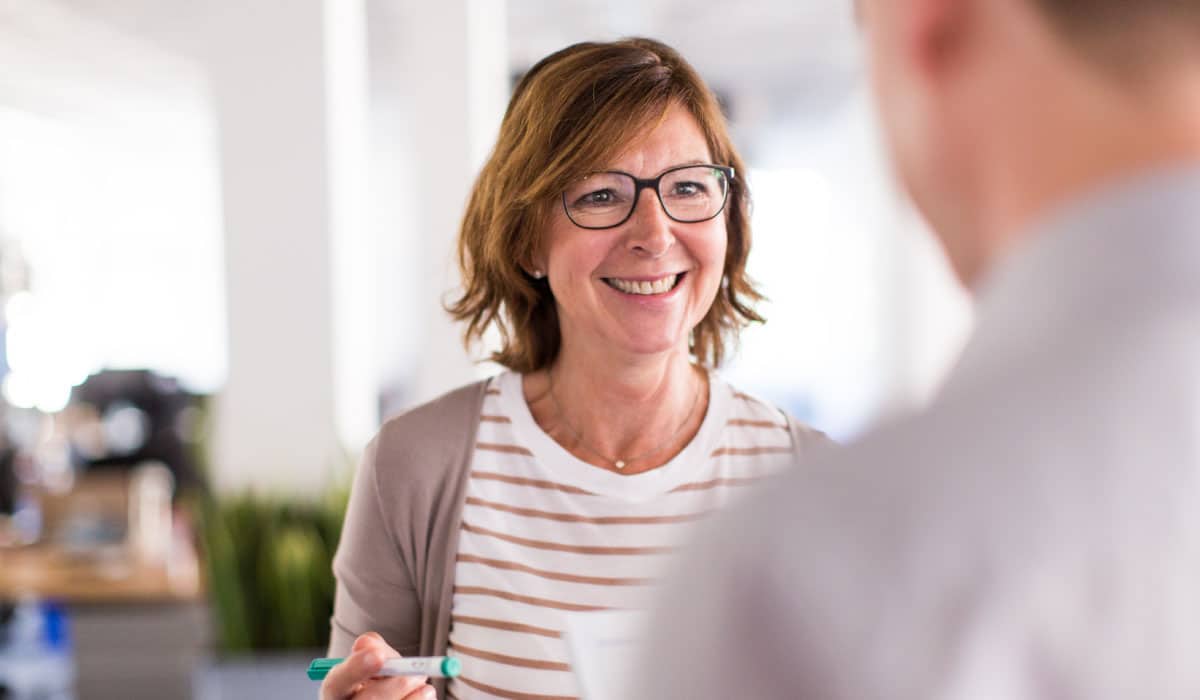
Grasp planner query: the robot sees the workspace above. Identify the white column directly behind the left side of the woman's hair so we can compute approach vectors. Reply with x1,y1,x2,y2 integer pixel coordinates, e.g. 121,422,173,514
372,0,509,406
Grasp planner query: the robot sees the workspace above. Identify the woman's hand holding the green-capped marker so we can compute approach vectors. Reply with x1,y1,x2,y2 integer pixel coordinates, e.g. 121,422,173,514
320,632,437,700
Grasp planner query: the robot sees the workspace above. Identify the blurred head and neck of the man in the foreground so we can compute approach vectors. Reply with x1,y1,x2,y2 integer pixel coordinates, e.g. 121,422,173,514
857,0,1200,286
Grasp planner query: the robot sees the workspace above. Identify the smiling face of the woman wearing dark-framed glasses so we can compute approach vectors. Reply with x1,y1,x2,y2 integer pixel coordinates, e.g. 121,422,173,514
540,106,726,365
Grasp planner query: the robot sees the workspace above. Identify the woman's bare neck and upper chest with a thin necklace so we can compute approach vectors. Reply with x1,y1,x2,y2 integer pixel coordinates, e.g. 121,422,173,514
524,348,708,474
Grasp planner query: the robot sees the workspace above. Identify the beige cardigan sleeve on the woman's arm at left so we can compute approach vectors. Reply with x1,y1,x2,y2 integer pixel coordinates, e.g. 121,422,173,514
329,436,421,657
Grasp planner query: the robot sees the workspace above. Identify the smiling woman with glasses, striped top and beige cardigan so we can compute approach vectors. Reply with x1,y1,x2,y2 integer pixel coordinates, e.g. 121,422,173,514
323,40,823,700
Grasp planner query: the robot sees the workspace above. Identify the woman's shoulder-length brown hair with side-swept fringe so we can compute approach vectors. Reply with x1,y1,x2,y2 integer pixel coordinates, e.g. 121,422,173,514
448,38,762,372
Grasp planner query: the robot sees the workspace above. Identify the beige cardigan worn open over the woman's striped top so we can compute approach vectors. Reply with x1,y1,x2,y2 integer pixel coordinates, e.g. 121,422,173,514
329,382,828,698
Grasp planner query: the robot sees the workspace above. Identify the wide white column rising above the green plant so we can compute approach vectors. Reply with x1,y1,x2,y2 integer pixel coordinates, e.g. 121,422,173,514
204,0,374,493
